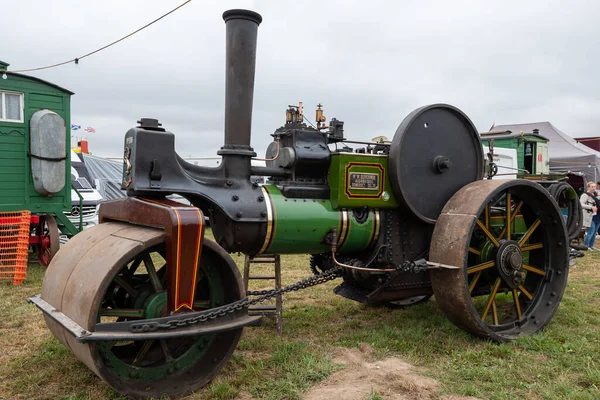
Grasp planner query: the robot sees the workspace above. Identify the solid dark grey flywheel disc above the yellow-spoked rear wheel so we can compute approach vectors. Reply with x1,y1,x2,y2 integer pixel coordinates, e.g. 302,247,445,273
389,104,484,223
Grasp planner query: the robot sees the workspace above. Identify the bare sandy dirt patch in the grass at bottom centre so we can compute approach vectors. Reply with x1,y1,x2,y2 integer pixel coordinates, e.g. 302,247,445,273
302,346,473,400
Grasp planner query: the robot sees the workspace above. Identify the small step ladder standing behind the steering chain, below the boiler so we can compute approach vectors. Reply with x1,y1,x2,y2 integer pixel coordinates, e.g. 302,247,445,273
244,254,283,336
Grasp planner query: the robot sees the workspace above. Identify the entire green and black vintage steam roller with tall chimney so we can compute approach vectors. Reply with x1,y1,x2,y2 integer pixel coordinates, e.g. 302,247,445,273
30,10,569,398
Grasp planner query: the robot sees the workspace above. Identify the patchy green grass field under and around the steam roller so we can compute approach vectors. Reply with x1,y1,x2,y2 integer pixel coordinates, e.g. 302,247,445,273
0,244,600,400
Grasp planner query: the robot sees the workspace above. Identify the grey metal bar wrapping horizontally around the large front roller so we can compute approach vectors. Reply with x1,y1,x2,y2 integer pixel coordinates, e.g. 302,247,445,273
28,295,261,343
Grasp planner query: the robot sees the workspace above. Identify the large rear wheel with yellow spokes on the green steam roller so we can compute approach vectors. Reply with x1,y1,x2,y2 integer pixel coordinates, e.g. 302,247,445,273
430,180,569,341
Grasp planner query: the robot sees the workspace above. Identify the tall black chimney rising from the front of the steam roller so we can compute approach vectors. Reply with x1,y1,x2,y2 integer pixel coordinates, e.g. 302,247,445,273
219,10,262,157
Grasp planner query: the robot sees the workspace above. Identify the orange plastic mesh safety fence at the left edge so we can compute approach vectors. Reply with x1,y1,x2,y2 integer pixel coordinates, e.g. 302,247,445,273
0,211,31,285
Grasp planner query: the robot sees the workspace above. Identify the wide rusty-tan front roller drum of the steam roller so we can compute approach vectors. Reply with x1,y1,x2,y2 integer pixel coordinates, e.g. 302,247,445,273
41,222,244,398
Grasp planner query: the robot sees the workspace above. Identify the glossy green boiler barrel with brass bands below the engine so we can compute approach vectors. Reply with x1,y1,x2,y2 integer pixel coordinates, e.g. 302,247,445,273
259,185,381,254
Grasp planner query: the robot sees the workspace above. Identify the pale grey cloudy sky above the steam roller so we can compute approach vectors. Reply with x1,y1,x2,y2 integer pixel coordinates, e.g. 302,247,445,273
0,0,600,157
